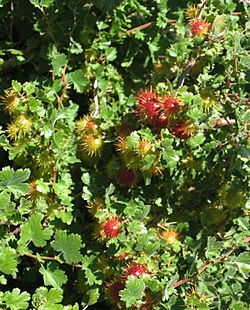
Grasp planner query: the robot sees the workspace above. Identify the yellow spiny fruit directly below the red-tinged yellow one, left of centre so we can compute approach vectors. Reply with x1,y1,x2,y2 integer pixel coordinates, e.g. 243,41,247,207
81,134,103,157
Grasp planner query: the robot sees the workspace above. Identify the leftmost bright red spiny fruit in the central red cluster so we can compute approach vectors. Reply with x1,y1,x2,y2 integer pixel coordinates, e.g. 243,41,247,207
137,90,160,121
